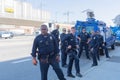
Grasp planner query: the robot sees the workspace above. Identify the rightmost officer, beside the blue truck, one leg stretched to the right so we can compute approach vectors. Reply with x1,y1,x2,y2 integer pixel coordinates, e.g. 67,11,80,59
97,31,110,58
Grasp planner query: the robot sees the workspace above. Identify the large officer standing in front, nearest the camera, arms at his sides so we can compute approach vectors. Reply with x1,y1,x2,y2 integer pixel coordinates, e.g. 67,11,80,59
31,25,66,80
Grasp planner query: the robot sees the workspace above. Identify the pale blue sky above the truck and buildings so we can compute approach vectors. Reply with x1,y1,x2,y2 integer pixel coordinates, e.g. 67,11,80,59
23,0,120,25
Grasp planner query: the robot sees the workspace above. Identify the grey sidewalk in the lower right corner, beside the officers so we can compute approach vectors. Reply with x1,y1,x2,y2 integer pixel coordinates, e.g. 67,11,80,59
79,47,120,80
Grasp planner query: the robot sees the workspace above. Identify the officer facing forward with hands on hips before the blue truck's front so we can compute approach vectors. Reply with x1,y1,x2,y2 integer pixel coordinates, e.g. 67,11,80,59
78,28,90,59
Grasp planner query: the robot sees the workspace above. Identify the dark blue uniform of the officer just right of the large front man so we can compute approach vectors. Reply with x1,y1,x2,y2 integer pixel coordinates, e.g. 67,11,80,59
67,34,80,76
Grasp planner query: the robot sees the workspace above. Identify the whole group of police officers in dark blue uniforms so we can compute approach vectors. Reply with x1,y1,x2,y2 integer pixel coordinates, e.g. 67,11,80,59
31,25,109,80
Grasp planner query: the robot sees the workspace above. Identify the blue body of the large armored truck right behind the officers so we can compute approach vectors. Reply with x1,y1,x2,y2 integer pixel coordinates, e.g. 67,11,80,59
75,17,115,49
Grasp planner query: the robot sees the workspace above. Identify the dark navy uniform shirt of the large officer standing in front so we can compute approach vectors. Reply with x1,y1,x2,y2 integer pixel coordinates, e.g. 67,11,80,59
31,34,59,57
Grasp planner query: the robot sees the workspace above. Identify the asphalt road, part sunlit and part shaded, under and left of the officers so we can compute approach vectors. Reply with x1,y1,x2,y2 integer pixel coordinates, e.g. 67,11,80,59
0,36,117,80
